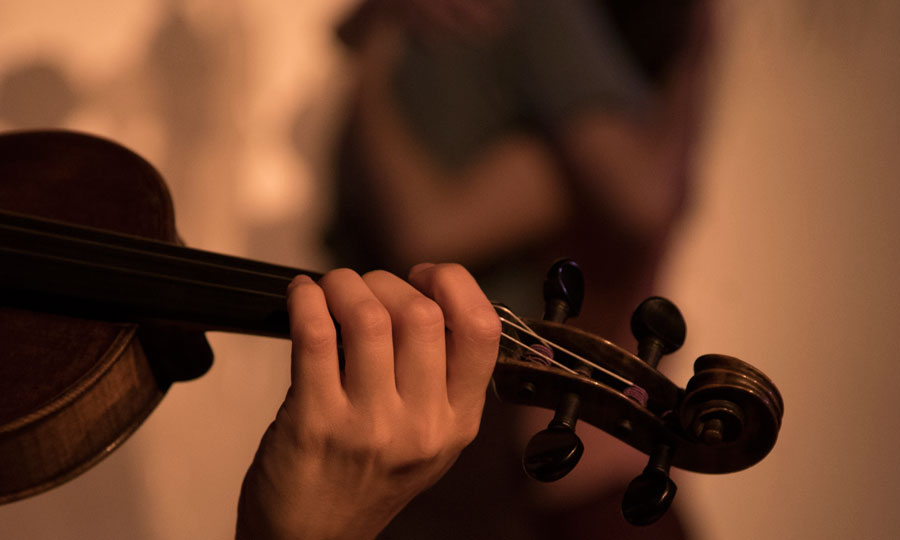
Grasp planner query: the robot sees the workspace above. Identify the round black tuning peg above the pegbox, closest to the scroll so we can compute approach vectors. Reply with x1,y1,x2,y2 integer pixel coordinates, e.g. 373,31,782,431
631,296,687,368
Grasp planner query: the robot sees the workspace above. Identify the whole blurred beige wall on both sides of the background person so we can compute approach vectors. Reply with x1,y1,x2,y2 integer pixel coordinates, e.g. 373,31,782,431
0,0,900,540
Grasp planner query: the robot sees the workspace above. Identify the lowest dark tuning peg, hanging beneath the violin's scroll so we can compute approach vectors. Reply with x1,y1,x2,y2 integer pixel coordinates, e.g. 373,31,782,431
622,444,678,525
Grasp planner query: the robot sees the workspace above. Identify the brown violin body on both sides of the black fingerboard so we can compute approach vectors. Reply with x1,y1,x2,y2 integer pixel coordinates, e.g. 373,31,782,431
0,132,212,503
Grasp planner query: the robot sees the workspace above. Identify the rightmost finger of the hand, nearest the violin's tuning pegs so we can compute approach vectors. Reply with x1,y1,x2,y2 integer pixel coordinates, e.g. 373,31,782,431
409,264,500,414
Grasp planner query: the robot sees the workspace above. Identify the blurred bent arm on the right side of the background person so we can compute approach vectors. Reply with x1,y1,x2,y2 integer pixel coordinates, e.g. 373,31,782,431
557,0,712,245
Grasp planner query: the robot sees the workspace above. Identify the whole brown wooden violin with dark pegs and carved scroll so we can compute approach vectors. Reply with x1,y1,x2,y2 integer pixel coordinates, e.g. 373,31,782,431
0,131,784,525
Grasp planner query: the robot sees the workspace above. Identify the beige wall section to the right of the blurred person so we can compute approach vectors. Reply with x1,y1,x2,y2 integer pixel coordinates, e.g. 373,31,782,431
667,2,900,540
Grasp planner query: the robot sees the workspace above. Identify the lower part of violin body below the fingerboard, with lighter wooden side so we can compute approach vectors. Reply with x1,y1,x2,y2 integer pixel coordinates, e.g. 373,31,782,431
0,308,164,503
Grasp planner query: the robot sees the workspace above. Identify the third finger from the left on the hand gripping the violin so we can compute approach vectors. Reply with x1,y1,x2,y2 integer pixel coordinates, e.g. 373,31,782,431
363,271,447,407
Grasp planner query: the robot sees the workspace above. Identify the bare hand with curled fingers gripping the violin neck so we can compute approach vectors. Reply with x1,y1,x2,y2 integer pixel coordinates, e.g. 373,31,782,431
237,264,500,540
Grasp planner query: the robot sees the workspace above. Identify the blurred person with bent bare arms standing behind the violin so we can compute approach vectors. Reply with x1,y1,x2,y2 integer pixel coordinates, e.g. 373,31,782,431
329,0,710,538
